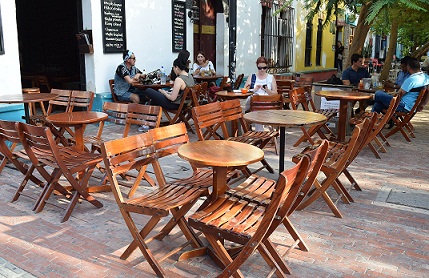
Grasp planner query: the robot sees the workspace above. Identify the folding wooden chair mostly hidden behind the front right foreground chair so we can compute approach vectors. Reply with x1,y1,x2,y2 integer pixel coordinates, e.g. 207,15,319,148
226,140,328,251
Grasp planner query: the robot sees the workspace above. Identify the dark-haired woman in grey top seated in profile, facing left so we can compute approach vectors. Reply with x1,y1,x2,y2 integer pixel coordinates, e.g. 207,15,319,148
146,58,195,110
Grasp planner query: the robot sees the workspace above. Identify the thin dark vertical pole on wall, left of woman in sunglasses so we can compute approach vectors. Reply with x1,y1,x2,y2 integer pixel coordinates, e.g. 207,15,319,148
229,0,237,86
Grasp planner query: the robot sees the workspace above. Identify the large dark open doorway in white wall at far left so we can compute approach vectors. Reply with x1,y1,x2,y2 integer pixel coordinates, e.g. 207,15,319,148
15,0,86,92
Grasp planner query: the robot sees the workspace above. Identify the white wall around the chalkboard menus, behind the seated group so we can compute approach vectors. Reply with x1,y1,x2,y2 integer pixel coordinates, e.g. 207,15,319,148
87,0,193,93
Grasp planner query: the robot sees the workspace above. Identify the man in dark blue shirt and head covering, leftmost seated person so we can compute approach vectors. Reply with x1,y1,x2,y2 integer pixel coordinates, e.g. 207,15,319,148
115,50,146,103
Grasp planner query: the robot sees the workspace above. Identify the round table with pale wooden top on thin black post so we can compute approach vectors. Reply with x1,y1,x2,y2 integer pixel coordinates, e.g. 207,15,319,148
244,110,327,173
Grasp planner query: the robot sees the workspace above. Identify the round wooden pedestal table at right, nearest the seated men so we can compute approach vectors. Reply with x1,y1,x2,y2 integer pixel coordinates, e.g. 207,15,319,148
316,91,373,142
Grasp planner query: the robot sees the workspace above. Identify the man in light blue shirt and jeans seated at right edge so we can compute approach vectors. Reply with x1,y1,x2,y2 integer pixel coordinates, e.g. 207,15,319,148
372,58,429,113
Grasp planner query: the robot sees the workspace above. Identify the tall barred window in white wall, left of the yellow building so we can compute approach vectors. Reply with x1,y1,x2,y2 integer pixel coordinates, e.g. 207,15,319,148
261,3,295,73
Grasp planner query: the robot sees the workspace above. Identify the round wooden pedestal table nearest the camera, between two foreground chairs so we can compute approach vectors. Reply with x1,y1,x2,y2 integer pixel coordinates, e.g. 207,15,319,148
178,140,264,200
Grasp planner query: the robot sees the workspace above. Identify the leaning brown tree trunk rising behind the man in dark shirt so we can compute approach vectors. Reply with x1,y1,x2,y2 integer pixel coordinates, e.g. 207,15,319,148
346,1,372,68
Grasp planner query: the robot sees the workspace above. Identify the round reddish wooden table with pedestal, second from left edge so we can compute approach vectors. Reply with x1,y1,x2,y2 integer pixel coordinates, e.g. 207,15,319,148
46,111,107,151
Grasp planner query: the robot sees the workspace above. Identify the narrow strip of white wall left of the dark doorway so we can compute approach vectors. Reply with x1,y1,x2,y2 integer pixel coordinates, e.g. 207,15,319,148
0,0,21,96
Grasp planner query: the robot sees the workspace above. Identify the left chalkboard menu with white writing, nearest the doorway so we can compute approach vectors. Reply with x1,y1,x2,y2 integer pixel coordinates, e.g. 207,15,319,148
101,0,126,53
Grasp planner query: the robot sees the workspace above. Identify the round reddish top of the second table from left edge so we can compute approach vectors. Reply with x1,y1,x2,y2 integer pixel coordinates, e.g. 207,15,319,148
46,111,107,125
